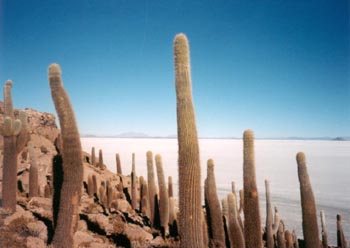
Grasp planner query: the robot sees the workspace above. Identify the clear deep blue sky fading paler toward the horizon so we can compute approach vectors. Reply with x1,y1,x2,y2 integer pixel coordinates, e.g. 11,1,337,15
0,0,350,137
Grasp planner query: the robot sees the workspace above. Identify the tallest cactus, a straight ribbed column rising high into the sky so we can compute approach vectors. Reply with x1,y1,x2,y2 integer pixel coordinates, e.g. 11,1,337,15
174,34,203,248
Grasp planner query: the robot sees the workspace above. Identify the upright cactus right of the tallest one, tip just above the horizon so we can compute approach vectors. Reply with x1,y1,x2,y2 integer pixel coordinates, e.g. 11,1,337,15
243,130,262,247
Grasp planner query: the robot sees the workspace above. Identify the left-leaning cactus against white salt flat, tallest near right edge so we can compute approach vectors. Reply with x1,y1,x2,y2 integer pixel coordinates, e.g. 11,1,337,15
296,152,320,248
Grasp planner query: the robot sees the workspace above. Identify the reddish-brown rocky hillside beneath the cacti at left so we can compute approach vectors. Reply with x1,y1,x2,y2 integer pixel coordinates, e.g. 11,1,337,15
0,102,178,248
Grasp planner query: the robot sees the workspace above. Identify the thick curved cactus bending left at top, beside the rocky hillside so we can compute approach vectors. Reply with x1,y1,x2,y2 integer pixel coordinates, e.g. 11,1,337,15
49,64,83,248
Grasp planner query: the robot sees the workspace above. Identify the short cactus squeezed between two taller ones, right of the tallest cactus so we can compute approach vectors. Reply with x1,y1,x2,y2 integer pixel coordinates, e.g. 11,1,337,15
227,193,245,248
